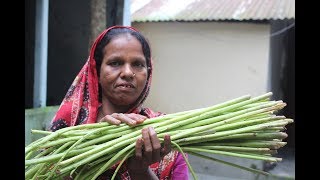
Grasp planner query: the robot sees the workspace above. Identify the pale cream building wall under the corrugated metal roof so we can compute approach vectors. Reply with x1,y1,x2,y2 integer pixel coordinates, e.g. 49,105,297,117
132,22,270,113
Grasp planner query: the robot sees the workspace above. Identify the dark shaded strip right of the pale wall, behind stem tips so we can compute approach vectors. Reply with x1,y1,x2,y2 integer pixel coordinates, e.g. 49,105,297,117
269,20,299,147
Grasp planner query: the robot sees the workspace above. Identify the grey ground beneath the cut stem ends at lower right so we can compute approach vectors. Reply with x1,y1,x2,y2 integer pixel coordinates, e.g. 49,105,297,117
189,148,295,180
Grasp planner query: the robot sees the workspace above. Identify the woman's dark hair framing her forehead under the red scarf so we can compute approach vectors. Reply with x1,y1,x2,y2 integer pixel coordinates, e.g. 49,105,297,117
94,28,151,77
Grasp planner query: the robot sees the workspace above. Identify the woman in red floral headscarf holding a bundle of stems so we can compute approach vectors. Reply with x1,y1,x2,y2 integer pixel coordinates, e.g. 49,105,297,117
51,26,188,180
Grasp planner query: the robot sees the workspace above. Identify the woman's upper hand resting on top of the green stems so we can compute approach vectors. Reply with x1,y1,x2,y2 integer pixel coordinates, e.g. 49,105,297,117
100,113,147,126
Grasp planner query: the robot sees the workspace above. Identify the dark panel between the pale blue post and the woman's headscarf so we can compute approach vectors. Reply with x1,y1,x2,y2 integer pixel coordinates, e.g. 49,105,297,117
47,0,91,106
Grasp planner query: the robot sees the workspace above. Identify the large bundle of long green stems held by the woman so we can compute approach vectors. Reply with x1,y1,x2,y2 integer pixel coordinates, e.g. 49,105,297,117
25,92,293,179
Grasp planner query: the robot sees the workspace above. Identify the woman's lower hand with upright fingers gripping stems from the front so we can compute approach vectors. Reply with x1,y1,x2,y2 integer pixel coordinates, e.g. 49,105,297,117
128,127,171,179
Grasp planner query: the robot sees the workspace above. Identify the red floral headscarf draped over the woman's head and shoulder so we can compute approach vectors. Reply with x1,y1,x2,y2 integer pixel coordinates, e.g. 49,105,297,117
50,26,155,131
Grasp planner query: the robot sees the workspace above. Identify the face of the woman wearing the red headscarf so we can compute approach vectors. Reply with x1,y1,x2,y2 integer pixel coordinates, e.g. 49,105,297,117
99,34,148,106
